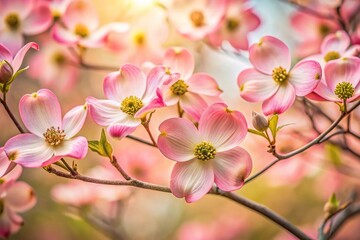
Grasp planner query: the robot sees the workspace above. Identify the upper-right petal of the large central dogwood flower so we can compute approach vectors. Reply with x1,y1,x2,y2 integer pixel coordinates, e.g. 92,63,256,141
199,103,248,152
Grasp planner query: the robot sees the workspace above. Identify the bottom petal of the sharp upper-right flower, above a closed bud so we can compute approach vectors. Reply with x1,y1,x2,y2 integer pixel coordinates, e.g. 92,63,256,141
262,83,296,116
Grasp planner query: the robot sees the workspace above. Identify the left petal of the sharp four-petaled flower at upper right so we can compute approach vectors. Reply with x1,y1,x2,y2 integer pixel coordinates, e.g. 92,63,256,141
237,68,279,102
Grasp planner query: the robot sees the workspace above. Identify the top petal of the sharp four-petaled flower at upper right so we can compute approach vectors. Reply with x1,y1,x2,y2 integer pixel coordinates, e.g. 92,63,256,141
249,36,291,74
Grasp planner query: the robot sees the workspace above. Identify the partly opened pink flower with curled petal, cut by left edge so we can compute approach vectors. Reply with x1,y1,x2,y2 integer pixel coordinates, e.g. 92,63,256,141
0,42,39,84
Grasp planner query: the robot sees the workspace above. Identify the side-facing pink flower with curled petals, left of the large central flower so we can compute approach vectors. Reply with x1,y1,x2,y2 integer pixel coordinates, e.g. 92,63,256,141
86,64,170,138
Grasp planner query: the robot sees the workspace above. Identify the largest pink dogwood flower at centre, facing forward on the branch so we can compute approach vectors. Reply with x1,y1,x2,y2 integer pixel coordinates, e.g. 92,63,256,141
158,103,252,202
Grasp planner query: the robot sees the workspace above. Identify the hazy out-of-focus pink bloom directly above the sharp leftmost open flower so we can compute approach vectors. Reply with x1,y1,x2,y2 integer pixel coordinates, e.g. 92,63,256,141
28,39,79,92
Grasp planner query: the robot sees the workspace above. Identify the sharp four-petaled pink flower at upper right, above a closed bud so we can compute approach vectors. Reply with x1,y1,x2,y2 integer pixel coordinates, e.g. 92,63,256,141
238,36,322,115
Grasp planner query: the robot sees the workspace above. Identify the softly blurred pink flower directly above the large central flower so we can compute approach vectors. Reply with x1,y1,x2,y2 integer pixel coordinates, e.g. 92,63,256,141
161,47,222,121
